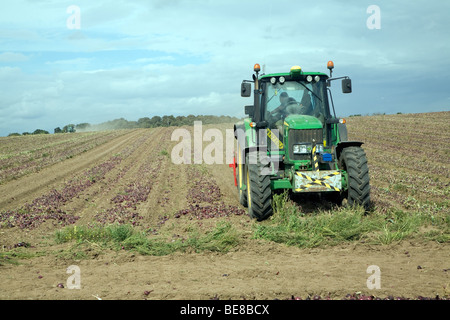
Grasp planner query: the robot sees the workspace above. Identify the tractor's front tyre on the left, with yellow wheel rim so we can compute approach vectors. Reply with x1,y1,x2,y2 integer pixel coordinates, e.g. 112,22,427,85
246,151,273,221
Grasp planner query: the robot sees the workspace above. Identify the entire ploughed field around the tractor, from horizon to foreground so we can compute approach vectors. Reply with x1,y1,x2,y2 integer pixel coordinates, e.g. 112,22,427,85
0,112,450,299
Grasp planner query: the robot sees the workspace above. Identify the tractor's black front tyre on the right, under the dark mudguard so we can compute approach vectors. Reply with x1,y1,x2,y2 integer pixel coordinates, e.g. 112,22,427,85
339,147,370,211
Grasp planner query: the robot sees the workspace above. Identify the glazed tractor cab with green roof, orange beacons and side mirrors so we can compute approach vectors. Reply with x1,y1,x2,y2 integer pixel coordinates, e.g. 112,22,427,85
241,61,351,156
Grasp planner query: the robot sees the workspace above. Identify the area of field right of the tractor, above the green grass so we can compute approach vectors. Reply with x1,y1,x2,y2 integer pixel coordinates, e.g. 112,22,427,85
347,112,450,214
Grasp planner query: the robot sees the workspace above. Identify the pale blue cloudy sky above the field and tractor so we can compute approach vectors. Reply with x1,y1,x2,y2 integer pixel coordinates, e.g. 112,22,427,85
0,0,450,136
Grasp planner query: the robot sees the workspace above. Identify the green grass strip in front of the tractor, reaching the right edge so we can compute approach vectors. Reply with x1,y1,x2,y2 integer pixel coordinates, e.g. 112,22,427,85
253,190,450,248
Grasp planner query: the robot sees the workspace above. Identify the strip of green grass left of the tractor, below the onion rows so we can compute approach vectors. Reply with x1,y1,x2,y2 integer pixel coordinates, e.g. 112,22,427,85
54,221,241,258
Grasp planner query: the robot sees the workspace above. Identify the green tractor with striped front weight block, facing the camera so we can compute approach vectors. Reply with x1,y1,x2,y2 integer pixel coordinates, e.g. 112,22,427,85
230,61,370,221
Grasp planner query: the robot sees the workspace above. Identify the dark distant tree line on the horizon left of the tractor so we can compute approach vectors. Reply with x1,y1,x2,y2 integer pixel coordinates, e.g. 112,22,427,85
8,115,239,136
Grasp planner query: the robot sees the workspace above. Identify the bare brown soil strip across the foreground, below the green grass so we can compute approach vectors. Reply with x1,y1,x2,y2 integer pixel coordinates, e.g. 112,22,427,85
0,241,450,299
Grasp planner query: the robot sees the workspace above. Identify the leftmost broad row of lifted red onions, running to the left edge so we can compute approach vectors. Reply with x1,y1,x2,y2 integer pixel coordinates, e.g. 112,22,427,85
0,132,151,229
